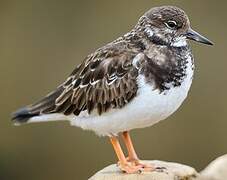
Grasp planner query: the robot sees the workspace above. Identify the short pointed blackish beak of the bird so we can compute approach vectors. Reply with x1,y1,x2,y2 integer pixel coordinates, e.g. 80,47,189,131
186,28,213,45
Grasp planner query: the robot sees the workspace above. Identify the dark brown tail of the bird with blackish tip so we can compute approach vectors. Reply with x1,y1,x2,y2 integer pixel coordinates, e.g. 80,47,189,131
12,87,63,125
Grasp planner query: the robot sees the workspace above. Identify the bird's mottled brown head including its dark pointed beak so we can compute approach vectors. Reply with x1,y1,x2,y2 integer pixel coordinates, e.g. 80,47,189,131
139,6,213,47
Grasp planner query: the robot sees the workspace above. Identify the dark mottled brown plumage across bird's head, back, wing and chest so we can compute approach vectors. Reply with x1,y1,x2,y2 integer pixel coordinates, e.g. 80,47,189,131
13,6,212,122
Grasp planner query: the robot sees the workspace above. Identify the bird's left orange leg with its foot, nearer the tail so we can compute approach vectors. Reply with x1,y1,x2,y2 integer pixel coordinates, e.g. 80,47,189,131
110,137,141,174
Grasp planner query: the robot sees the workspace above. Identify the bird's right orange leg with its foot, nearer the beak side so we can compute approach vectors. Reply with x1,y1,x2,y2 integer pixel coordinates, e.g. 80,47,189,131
122,131,155,171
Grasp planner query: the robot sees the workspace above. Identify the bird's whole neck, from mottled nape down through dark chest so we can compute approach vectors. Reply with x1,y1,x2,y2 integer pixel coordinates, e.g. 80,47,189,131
124,29,193,92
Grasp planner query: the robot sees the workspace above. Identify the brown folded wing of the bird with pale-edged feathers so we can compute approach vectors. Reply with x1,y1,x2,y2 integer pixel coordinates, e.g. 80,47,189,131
52,50,138,115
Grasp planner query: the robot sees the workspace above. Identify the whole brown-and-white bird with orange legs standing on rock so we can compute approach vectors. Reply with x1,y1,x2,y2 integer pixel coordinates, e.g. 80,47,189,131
12,6,213,174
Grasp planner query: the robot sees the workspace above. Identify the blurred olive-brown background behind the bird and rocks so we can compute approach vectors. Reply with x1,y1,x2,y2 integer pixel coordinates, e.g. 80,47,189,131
0,0,227,180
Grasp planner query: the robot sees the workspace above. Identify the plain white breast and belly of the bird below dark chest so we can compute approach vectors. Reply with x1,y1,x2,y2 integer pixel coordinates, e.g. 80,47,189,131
68,57,193,135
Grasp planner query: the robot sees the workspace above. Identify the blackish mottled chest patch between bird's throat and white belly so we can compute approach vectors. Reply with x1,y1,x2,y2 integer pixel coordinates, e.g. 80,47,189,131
141,44,193,92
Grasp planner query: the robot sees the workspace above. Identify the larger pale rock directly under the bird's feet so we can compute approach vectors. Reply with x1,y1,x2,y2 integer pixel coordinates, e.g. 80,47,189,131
89,161,199,180
